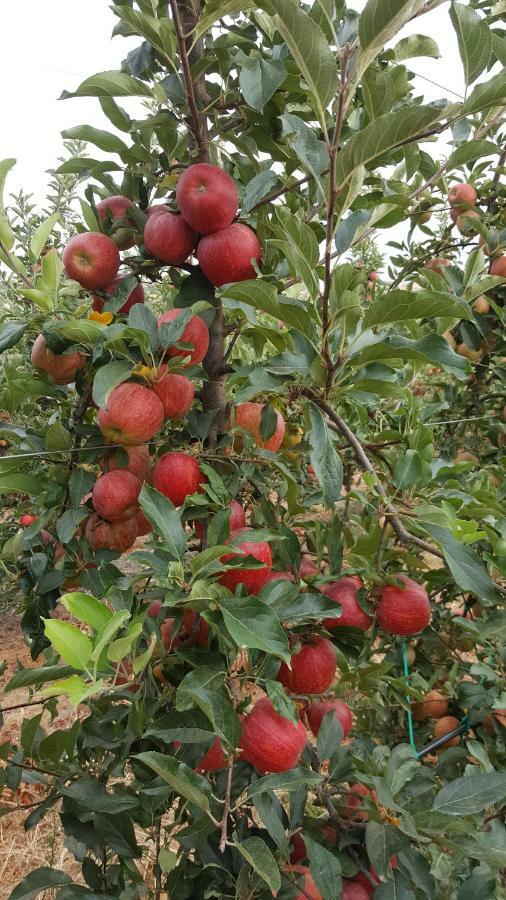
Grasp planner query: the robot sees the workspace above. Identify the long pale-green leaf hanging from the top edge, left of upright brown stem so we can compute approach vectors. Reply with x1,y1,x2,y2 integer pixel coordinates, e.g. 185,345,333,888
257,0,337,124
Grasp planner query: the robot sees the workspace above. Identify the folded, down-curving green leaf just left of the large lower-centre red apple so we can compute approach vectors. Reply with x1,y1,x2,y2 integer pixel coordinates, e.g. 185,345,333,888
176,666,240,749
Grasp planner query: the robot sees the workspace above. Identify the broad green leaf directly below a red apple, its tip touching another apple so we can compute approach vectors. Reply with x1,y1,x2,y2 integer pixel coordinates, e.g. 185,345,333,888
218,597,290,662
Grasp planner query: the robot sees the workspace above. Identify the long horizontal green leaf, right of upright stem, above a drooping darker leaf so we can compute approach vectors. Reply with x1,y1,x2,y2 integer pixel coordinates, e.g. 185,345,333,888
363,289,473,330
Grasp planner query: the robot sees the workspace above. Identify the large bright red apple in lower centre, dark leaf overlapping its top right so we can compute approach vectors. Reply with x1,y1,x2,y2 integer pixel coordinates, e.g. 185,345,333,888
241,697,306,774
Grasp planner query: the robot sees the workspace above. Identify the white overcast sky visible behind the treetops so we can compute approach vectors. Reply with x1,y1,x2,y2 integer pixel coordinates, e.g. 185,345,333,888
0,0,464,199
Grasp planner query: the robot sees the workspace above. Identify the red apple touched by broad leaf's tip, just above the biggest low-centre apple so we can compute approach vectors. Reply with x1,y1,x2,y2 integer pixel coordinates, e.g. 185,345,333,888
277,635,337,694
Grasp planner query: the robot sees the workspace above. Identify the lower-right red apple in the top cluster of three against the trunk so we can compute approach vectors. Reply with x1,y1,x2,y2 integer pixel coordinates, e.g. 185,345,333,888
197,222,262,287
